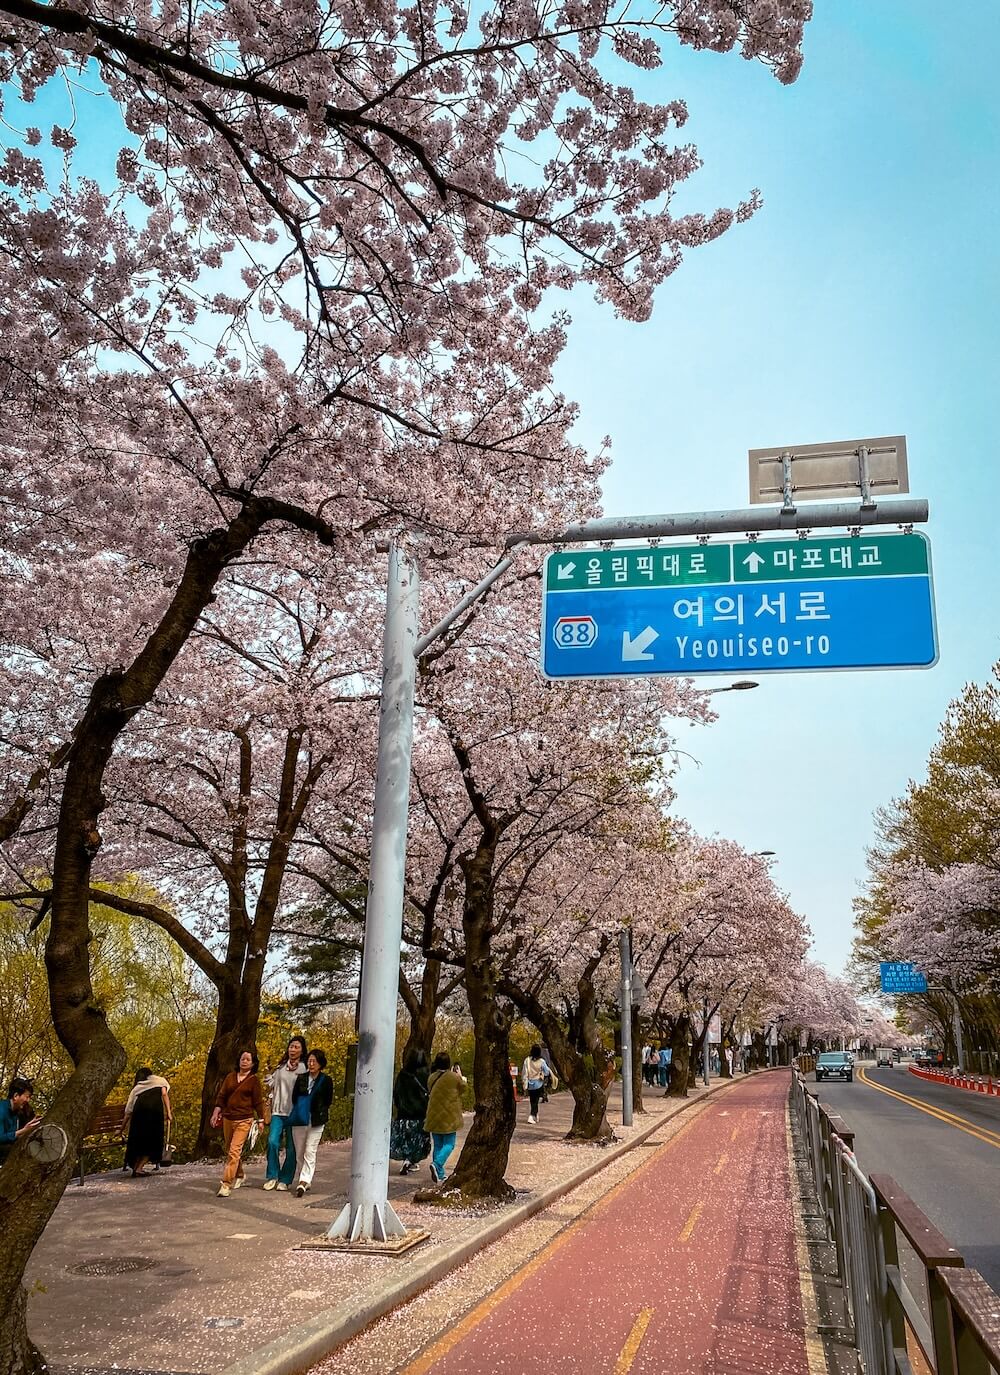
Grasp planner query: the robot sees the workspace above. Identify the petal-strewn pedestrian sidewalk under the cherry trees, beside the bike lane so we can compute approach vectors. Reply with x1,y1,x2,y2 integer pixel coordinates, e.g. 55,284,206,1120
28,1074,803,1375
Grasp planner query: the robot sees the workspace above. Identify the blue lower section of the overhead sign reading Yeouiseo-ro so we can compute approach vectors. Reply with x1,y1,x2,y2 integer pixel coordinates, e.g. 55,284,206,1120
542,536,938,679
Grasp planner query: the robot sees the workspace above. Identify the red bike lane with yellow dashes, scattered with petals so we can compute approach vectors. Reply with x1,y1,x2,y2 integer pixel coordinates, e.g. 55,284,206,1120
406,1071,809,1375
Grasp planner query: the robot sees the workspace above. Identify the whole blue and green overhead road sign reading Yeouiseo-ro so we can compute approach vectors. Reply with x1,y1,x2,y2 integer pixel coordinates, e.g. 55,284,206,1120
542,535,938,678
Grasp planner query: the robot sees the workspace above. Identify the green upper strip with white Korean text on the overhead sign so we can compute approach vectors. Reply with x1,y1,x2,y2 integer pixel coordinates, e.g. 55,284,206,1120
545,534,930,593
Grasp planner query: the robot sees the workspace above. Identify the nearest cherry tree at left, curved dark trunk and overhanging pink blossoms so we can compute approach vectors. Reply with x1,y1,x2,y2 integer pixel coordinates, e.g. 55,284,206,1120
0,0,810,1358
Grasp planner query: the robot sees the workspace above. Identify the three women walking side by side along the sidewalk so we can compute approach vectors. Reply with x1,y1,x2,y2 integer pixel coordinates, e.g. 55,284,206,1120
212,1035,333,1199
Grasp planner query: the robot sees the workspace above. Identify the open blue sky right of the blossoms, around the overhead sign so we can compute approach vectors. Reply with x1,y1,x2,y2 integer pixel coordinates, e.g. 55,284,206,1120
560,0,1000,969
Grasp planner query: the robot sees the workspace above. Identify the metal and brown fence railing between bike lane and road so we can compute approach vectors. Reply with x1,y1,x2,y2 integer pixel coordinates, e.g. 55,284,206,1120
792,1070,1000,1375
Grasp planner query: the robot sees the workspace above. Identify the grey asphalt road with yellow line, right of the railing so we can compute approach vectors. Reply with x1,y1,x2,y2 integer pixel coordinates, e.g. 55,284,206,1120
809,1063,1000,1293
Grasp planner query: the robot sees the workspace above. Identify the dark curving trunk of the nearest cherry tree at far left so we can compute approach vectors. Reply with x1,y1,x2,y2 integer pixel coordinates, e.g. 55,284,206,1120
0,498,331,1375
